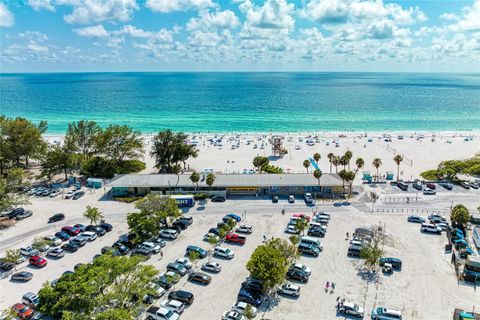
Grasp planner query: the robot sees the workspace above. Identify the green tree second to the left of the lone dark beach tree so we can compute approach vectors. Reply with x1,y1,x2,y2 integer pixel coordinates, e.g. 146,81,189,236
65,120,102,160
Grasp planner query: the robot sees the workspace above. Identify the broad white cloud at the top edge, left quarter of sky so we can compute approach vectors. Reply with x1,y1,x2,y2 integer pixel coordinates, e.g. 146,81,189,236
56,0,138,24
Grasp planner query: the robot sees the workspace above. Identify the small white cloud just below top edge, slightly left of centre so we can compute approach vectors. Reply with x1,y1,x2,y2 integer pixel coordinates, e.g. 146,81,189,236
186,10,240,31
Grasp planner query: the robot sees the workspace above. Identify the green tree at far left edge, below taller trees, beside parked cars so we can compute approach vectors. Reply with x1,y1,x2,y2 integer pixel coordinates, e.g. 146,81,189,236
0,168,30,211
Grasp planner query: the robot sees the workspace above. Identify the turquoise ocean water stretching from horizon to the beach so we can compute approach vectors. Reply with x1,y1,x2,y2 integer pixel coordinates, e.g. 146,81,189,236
0,73,480,133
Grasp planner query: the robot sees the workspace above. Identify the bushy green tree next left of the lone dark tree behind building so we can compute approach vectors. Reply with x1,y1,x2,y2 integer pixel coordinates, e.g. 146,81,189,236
97,125,145,164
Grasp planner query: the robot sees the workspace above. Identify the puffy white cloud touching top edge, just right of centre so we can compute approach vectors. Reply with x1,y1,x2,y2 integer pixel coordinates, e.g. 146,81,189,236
239,0,295,31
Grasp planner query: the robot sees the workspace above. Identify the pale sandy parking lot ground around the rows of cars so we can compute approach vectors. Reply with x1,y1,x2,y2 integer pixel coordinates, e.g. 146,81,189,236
0,194,480,319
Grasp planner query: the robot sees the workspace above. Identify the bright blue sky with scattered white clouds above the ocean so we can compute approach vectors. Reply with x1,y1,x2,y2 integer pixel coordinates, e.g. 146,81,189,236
0,0,480,73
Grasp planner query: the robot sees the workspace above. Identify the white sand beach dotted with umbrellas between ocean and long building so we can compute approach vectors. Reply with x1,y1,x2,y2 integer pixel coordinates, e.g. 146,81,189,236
43,132,480,182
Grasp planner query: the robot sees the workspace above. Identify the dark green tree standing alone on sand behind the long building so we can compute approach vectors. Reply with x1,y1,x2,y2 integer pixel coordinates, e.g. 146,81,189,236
150,130,198,173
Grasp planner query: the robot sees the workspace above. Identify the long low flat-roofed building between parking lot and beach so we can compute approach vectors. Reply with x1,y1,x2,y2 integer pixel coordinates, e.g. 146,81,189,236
107,173,348,197
